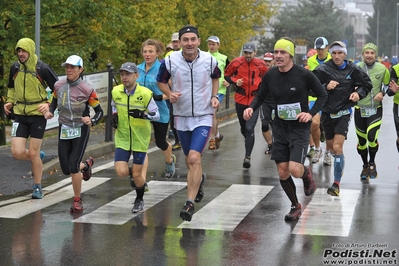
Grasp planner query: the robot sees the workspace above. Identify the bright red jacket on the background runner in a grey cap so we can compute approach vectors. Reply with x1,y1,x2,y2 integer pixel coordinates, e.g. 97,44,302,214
224,56,269,105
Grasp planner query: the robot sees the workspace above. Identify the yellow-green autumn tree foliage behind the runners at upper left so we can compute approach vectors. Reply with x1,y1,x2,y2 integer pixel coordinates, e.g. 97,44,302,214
0,0,272,144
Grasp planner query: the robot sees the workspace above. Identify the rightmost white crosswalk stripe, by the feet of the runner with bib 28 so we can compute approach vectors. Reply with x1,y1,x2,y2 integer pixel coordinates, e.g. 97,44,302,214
292,188,360,237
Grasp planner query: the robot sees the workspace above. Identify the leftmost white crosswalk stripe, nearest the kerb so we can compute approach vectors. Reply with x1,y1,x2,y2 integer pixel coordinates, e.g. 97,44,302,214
0,177,110,219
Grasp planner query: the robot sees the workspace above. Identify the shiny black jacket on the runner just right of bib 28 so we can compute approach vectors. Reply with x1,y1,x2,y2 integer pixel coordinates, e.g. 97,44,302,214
313,60,373,114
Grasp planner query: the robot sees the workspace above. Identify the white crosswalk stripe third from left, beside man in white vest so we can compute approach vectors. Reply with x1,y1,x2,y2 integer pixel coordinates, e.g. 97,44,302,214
178,184,273,231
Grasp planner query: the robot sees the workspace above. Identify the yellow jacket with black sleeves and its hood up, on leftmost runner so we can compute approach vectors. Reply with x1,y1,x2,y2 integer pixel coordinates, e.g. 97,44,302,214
7,38,58,116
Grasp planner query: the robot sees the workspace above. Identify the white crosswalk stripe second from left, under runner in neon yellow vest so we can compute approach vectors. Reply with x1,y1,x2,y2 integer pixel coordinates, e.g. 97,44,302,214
73,181,187,225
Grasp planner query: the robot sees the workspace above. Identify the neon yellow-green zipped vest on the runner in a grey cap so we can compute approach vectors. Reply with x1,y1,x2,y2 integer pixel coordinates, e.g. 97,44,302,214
112,83,152,152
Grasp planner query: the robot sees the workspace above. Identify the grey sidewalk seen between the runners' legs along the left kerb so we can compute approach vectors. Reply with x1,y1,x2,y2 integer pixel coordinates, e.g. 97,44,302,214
0,94,235,190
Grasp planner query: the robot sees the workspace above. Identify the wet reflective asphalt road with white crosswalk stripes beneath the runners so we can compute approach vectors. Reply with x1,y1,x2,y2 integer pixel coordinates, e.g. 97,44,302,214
0,98,399,266
